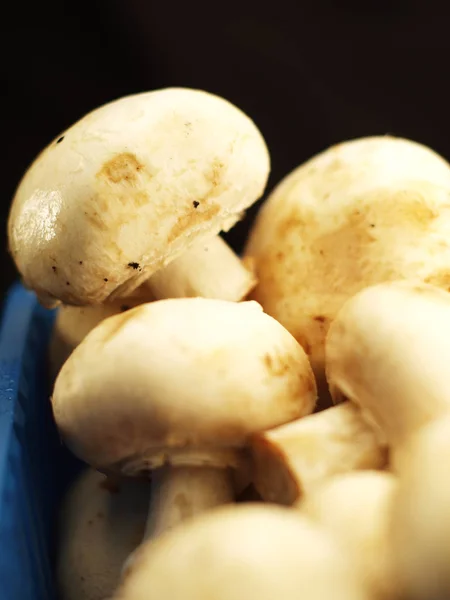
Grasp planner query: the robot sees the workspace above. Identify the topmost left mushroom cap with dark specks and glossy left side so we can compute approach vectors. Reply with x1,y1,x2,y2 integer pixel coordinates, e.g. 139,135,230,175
8,88,270,305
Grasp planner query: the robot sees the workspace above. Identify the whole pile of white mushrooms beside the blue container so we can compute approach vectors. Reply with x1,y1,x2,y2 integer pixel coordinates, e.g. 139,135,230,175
8,88,450,600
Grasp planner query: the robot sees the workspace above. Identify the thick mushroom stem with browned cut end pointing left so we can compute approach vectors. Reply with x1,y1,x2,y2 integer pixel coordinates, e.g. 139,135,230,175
251,402,387,505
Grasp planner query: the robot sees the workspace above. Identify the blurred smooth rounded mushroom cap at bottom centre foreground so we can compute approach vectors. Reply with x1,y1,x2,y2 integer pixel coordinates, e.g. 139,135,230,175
113,504,368,600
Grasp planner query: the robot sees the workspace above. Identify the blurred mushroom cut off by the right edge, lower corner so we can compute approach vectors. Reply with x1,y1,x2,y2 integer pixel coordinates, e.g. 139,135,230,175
392,414,450,600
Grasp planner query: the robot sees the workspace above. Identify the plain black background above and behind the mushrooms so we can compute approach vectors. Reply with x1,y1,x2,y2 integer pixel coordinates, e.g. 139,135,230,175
0,0,450,294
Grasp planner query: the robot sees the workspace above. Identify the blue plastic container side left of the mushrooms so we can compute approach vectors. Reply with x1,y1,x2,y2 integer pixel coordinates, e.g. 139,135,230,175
0,284,80,600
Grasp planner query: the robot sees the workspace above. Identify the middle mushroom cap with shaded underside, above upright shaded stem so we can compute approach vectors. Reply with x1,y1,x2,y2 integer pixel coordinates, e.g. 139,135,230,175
52,298,316,475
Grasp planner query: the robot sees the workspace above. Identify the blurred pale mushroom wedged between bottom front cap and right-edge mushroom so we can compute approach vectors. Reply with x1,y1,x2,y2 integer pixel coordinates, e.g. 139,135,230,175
297,471,398,600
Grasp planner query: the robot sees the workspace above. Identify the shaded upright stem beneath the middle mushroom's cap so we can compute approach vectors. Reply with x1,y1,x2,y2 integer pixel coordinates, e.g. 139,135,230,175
144,466,234,540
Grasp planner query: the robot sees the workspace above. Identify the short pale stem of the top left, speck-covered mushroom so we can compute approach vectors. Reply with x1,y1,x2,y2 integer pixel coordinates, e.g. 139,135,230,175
147,236,256,301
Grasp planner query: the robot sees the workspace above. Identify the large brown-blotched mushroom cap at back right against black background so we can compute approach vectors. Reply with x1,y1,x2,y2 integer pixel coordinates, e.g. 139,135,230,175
245,137,450,379
